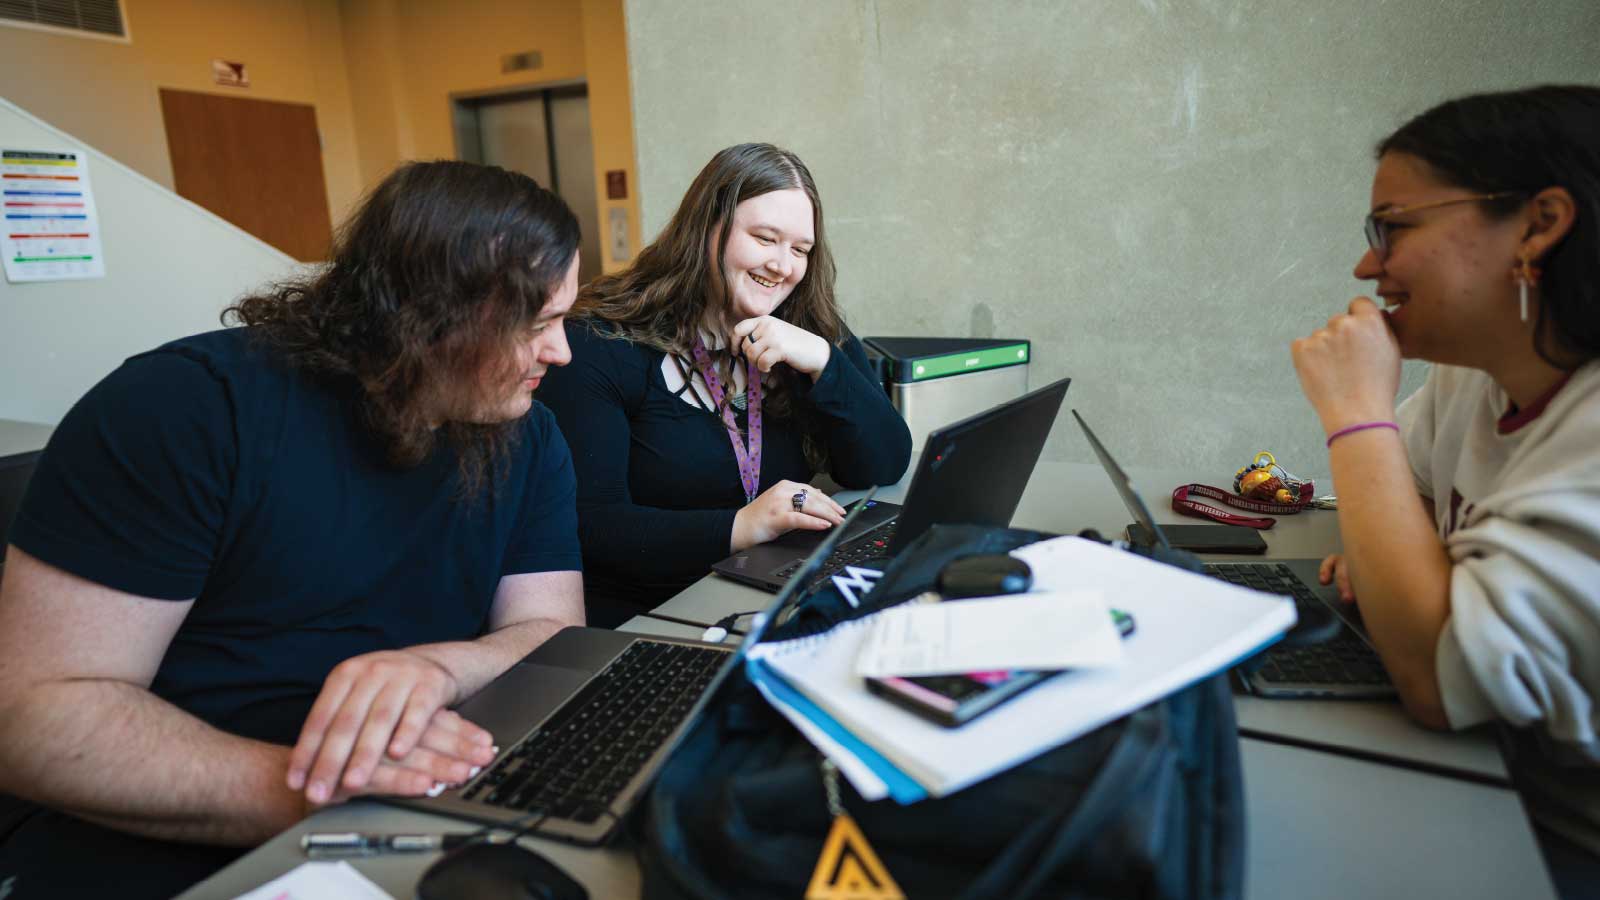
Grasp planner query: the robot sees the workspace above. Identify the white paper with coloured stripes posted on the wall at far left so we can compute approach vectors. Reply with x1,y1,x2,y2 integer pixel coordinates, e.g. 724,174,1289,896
0,147,106,282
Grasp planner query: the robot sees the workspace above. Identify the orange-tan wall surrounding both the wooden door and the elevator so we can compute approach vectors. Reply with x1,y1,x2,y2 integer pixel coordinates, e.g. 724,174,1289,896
0,0,638,261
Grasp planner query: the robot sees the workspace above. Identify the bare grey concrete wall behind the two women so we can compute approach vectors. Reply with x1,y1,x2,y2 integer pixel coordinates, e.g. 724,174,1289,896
627,0,1600,477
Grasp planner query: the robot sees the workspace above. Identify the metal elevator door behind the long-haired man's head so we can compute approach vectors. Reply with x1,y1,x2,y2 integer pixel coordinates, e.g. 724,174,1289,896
454,86,600,283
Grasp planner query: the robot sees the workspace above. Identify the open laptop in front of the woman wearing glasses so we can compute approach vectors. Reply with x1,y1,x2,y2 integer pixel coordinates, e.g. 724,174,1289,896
1072,410,1395,700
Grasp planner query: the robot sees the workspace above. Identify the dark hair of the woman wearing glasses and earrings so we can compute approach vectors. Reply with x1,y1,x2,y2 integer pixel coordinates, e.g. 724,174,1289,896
1378,85,1600,370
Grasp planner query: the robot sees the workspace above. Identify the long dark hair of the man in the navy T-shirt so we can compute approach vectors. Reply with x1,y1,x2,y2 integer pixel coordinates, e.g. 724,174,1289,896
222,160,579,495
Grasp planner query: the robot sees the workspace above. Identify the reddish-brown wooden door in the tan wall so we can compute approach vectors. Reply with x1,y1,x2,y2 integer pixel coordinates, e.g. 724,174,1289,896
162,88,333,261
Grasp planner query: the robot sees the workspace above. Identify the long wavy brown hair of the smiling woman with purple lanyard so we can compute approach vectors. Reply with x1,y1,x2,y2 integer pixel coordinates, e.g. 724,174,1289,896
573,144,846,469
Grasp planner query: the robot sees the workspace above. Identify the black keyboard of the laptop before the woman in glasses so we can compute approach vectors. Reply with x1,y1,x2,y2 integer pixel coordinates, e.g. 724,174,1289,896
1205,562,1389,687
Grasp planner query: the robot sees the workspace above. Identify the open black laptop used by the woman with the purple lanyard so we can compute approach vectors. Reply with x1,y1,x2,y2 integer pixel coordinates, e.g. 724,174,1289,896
712,378,1072,591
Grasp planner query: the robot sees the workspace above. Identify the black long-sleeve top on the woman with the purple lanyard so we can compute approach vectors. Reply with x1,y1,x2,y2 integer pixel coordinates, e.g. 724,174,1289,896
538,322,910,610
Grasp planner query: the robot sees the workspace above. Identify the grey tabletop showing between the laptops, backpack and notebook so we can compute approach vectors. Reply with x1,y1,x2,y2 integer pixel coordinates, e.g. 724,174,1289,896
182,461,1554,900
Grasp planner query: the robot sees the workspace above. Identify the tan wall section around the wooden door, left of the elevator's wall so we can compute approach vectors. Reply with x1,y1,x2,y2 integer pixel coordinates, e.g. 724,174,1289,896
0,0,362,227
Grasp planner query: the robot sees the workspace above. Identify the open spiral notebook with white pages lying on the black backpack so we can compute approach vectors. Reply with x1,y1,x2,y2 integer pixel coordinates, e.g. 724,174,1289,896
746,528,1294,802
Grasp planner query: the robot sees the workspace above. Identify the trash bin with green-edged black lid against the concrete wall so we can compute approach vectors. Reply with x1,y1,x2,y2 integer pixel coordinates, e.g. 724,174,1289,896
861,338,1032,450
